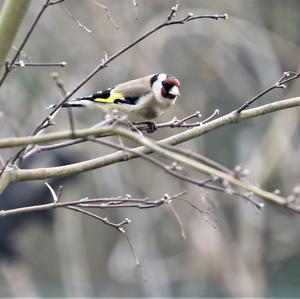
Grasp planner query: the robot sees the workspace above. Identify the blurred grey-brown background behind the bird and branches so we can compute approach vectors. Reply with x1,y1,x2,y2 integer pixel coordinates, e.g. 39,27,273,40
0,0,300,297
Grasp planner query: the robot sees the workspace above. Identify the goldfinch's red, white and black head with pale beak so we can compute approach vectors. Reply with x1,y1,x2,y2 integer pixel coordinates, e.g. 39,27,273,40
151,73,180,104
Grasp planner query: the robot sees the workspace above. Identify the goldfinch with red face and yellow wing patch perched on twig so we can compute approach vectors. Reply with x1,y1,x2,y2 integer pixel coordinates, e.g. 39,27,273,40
49,73,180,120
